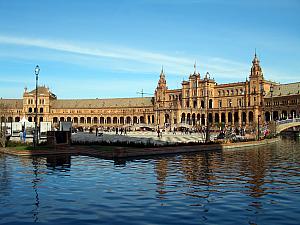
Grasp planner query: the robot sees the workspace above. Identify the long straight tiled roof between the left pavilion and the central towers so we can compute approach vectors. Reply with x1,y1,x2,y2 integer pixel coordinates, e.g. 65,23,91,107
51,97,153,109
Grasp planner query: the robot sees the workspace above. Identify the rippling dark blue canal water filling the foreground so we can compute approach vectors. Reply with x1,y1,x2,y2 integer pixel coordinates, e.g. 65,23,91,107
0,140,300,225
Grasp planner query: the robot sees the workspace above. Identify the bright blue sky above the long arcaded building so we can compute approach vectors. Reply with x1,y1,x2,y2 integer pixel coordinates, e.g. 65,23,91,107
0,0,300,98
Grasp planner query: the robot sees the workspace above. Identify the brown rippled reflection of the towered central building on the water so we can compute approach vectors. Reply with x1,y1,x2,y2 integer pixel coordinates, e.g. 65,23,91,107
155,149,272,216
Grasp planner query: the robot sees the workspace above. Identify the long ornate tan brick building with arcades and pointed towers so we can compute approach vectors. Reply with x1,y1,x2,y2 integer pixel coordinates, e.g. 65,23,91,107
0,54,300,130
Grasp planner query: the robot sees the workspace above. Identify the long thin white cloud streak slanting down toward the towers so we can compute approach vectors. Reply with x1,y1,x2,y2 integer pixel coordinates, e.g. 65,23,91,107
0,35,248,78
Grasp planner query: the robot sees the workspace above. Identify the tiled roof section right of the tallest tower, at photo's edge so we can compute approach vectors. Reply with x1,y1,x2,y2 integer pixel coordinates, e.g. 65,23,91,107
265,82,300,98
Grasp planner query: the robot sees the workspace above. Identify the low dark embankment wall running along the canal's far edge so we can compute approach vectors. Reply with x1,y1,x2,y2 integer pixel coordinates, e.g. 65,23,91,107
0,138,280,159
